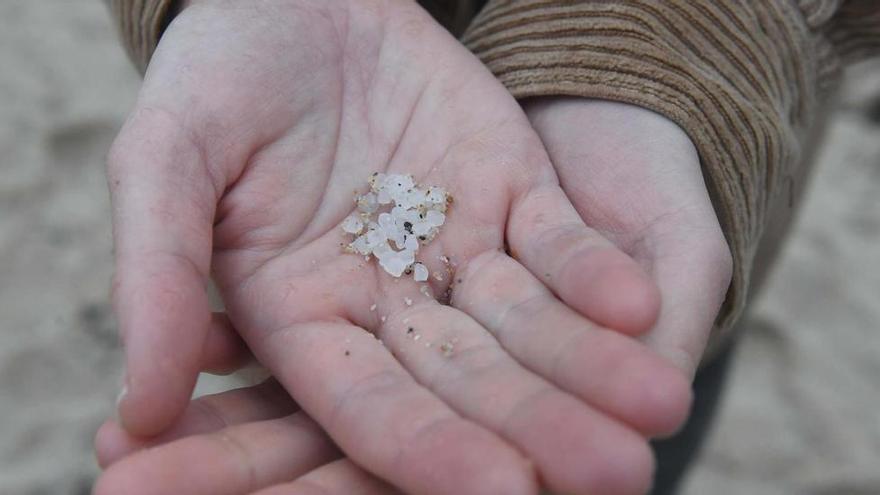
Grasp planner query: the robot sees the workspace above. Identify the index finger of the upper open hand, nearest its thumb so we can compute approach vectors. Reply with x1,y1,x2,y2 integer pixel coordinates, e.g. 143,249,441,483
252,323,537,495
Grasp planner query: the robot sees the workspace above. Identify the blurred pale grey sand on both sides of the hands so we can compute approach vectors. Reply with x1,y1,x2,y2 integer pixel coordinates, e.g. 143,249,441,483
0,0,880,495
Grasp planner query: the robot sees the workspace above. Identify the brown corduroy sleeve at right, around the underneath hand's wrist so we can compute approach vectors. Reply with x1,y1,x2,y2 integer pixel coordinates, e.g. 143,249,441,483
464,0,880,348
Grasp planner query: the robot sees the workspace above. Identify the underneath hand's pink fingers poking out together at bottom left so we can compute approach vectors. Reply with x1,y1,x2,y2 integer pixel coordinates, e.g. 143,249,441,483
96,379,399,495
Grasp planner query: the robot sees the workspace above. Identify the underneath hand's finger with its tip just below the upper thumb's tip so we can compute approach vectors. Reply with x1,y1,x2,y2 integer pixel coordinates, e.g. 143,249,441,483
95,379,297,468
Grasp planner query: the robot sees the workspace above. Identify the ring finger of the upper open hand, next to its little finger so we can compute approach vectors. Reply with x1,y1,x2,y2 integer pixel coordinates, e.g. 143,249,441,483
453,252,691,435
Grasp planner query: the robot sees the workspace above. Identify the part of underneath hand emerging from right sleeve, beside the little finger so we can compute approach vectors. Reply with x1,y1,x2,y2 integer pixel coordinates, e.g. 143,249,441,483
523,97,732,379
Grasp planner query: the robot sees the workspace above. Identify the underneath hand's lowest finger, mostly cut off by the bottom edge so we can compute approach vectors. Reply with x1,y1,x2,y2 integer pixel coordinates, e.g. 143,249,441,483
254,459,401,495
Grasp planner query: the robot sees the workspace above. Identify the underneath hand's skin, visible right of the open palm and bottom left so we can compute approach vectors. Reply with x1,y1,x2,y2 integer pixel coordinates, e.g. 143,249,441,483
96,98,730,494
